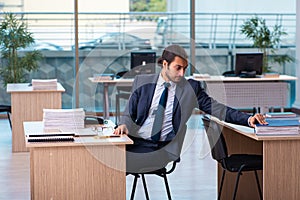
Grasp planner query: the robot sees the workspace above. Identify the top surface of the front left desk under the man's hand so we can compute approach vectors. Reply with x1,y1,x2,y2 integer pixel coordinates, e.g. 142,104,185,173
23,121,133,147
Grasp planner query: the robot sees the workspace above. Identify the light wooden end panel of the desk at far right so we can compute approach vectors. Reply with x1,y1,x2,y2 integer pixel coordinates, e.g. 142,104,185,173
263,139,300,200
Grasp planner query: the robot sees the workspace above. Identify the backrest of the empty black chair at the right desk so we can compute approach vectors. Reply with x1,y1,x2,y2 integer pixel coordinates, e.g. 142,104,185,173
202,116,228,162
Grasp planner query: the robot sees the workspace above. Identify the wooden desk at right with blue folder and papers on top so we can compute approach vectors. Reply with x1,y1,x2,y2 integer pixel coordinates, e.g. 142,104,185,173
213,118,300,200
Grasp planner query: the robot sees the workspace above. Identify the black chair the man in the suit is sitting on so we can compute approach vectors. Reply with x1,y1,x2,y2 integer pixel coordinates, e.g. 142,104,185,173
126,158,180,200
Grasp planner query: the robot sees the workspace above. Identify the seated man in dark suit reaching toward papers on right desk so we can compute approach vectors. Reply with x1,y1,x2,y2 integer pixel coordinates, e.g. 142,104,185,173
115,45,266,172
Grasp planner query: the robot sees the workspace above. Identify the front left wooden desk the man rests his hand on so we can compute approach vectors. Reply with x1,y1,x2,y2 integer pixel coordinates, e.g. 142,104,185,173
24,122,133,200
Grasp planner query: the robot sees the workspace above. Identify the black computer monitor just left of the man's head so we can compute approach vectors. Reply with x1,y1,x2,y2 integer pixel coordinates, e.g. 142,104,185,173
130,51,156,76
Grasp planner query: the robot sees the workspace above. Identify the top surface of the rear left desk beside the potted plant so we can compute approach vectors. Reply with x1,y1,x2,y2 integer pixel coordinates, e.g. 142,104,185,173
6,83,65,93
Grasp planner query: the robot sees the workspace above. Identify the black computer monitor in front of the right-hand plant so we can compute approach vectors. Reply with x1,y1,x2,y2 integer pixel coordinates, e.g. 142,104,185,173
235,53,263,77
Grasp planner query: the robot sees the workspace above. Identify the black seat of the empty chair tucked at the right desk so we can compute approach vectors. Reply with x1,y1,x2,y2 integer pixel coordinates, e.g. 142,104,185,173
224,154,263,172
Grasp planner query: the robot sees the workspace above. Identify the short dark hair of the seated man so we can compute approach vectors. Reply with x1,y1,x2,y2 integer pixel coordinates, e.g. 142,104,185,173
157,44,188,66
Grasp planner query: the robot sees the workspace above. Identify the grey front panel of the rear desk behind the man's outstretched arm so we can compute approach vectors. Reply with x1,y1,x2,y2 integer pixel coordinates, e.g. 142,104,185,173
207,82,288,108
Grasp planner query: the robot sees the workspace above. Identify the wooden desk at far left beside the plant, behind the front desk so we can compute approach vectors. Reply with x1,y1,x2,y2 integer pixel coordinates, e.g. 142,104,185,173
7,83,65,152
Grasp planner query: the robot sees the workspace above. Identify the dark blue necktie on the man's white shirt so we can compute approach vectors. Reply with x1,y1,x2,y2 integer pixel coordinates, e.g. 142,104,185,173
151,82,171,142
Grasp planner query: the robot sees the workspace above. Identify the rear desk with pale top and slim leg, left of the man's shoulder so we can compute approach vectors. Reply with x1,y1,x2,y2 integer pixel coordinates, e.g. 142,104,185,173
89,77,133,119
